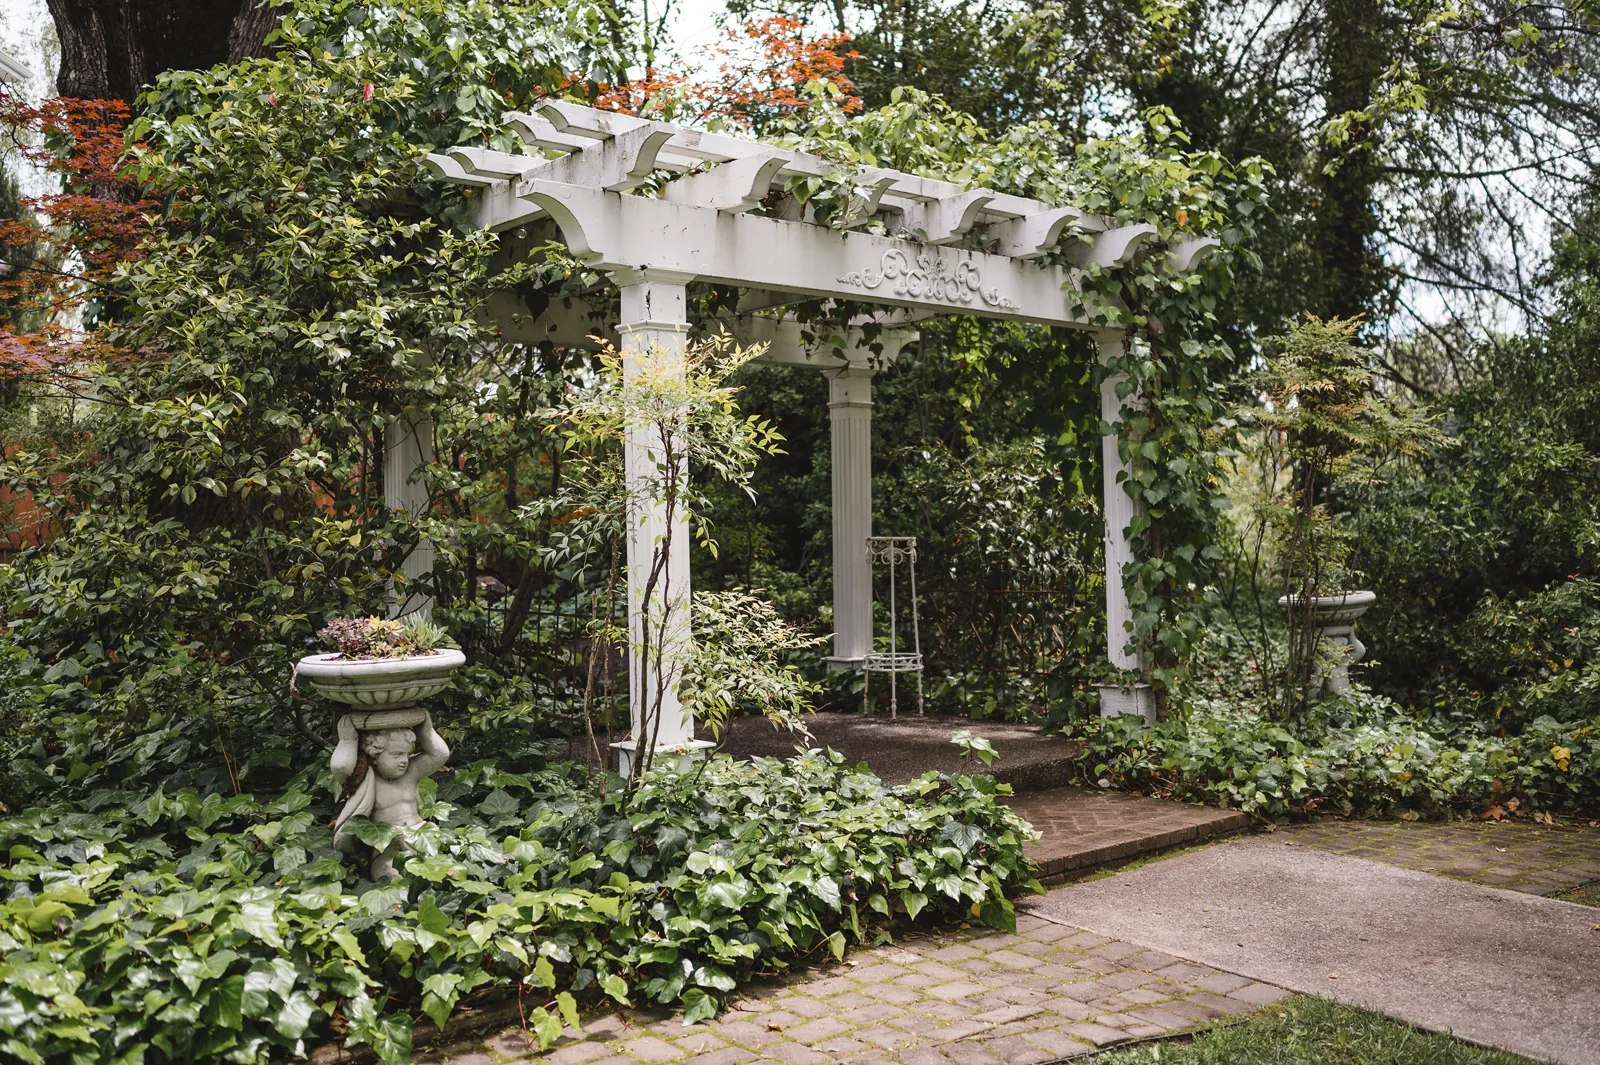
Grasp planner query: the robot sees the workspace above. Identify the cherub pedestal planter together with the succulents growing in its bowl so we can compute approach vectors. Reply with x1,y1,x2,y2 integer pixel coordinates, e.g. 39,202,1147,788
294,617,467,880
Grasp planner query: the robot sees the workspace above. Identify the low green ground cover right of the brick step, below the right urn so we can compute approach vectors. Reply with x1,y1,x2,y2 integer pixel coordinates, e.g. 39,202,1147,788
1072,691,1600,822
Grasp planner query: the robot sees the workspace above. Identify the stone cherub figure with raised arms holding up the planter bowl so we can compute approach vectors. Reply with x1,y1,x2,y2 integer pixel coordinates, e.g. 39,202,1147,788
330,712,450,880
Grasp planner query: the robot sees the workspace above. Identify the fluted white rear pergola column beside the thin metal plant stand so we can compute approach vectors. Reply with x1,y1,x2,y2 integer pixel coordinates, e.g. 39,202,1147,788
827,363,872,668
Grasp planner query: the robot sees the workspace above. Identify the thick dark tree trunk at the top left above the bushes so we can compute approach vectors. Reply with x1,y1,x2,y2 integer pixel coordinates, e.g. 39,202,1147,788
46,0,280,104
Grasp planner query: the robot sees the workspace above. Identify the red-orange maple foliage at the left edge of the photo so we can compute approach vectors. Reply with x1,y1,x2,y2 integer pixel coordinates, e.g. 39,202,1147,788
0,88,160,377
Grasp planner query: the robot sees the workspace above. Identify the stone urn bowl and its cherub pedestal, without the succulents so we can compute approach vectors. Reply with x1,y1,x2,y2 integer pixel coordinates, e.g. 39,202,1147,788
296,648,467,880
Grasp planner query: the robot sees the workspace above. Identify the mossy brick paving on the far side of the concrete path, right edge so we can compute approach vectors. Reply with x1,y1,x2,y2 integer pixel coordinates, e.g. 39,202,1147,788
1285,820,1600,895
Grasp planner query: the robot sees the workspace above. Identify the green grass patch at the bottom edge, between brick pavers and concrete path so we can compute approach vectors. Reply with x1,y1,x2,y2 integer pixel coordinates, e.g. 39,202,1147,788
1083,998,1534,1065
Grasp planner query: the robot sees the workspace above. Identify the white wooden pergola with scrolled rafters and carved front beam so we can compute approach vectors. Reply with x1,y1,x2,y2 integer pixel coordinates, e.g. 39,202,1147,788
406,101,1218,752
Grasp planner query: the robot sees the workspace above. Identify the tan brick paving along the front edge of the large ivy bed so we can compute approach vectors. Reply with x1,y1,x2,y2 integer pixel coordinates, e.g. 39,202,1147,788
435,916,1286,1065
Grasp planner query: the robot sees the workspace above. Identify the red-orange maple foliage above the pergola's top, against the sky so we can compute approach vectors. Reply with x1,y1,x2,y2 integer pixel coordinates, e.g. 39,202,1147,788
595,16,861,130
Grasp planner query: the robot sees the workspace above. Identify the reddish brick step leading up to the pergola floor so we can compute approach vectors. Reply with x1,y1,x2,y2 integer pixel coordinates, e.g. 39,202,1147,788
1006,788,1250,883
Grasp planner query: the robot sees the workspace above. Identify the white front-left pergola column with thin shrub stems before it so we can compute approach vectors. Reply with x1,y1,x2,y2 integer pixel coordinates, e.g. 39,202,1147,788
611,269,704,774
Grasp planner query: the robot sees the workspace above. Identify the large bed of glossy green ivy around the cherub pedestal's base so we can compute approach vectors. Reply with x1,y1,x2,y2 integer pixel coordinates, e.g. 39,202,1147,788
0,755,1037,1065
